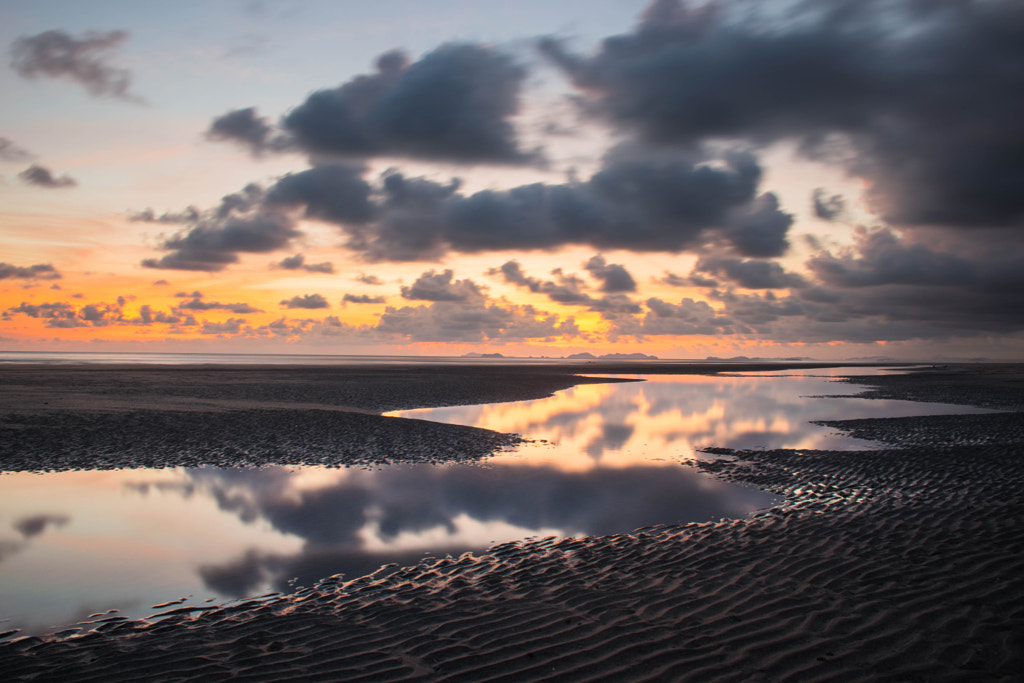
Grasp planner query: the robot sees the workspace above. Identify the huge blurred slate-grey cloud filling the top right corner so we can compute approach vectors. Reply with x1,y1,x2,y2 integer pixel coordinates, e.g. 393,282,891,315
542,0,1024,226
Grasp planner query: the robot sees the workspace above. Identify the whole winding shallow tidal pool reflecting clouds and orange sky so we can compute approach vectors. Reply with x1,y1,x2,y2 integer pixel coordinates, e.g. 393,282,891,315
0,371,991,634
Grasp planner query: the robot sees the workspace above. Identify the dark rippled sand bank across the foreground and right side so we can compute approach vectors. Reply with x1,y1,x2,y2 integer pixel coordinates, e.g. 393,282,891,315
0,360,1024,681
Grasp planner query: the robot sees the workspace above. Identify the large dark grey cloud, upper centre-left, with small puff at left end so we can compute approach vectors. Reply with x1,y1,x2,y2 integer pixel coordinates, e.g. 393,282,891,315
207,43,539,164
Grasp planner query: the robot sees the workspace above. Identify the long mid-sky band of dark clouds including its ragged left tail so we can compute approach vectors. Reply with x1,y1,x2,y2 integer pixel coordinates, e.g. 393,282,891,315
143,148,793,268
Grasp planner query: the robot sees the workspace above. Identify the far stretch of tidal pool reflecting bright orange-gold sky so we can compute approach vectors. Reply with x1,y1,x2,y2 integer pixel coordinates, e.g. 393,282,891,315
388,373,987,458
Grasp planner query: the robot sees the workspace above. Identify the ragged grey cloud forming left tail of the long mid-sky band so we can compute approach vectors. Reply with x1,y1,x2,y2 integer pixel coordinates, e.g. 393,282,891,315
142,184,301,271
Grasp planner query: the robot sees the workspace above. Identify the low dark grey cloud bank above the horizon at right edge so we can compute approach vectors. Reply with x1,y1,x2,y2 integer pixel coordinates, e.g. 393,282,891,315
626,229,1024,343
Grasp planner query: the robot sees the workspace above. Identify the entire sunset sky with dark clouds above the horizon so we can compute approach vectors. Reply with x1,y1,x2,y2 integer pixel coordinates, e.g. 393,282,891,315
0,0,1024,360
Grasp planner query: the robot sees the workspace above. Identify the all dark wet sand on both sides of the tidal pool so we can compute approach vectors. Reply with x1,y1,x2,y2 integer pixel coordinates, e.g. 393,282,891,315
0,365,1024,681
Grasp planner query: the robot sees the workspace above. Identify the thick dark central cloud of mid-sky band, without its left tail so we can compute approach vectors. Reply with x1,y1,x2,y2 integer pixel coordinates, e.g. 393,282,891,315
346,152,793,260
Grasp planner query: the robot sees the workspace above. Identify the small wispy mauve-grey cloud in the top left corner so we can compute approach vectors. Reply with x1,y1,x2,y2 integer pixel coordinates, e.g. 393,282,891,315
10,31,140,101
